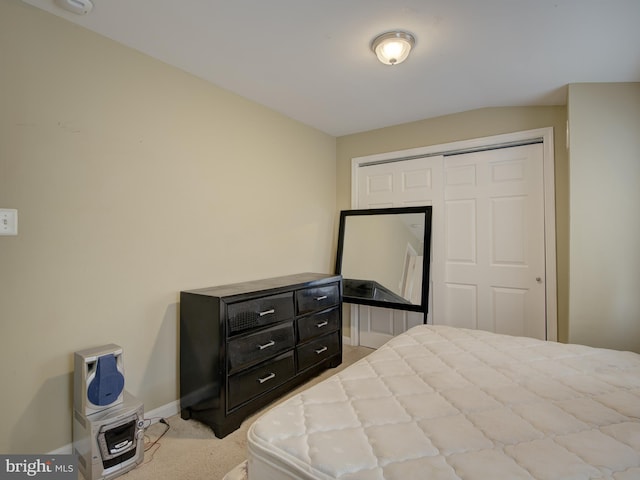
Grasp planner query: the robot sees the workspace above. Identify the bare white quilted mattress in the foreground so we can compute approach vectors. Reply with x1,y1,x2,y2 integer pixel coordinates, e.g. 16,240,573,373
248,325,640,480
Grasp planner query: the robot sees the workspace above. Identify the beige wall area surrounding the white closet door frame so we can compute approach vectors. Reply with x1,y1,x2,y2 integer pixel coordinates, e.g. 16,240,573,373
337,106,569,341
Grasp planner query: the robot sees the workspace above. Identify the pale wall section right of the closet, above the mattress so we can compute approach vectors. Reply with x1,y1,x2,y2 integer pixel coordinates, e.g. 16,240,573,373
568,83,640,353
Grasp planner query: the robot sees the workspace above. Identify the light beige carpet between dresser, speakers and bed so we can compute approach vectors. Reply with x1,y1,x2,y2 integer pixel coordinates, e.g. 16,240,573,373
119,345,372,480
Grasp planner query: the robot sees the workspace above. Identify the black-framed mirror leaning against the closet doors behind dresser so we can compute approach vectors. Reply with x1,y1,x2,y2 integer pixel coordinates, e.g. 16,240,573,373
336,206,431,314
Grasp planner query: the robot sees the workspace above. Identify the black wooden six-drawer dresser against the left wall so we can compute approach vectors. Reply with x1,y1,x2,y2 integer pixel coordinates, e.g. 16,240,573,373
180,273,342,438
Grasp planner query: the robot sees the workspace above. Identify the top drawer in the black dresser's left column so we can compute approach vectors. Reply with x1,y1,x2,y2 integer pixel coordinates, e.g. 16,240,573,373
227,292,293,335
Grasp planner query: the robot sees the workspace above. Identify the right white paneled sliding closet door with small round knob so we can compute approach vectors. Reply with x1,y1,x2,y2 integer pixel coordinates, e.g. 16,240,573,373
442,144,546,339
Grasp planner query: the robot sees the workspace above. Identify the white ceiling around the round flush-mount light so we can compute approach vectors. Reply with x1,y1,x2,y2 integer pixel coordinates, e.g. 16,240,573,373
23,0,640,136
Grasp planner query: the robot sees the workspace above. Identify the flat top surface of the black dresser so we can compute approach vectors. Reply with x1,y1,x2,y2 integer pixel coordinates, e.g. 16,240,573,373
184,272,342,297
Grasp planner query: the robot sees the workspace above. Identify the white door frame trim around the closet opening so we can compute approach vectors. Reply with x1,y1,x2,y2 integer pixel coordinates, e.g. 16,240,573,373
350,127,558,345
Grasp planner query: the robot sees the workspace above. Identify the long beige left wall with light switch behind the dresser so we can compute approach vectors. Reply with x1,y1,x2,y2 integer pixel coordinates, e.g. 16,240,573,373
0,0,336,453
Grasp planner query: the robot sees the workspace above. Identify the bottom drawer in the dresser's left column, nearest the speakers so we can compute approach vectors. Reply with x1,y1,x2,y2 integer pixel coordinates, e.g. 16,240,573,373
228,351,295,410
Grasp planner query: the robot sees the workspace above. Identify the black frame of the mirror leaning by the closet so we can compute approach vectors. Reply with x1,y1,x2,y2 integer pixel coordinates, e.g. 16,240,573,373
336,206,432,314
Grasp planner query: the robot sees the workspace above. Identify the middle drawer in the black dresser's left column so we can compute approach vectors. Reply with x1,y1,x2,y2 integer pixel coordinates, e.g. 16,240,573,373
228,322,295,373
